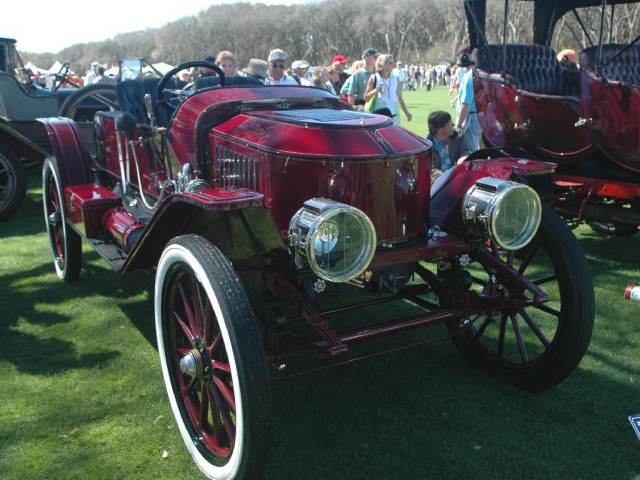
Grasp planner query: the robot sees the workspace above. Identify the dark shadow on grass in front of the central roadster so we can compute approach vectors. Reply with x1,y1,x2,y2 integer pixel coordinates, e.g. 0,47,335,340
264,341,640,480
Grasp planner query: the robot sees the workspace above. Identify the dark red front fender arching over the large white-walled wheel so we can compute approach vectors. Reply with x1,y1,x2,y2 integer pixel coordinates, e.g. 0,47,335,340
121,188,286,274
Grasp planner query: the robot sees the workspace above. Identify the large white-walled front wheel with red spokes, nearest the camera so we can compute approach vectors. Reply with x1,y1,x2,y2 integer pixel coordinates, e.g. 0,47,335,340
155,235,269,480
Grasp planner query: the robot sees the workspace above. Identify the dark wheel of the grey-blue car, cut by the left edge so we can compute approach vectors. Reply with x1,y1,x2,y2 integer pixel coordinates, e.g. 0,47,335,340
0,143,27,220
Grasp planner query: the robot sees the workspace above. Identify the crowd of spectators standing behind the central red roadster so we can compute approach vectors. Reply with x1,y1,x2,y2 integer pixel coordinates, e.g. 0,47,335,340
84,48,482,179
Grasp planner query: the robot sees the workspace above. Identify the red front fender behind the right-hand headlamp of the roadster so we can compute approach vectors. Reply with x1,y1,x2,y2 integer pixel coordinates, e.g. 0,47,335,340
430,154,556,231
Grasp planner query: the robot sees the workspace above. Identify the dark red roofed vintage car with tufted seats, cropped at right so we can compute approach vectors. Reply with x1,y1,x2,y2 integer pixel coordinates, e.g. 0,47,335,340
465,0,640,235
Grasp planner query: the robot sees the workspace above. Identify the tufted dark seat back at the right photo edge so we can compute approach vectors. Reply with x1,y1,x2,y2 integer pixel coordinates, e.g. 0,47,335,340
580,43,640,86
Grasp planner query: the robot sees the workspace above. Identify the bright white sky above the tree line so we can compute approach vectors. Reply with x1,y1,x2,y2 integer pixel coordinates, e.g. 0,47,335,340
0,0,303,53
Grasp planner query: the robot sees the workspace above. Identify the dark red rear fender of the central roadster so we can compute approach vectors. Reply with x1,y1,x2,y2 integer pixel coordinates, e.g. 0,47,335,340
37,117,93,186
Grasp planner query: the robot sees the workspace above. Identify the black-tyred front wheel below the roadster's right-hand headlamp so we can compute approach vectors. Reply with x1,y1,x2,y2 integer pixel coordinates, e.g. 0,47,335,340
449,206,595,391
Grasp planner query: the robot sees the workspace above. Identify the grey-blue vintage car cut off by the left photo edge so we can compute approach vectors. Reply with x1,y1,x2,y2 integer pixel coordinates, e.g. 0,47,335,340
0,38,117,220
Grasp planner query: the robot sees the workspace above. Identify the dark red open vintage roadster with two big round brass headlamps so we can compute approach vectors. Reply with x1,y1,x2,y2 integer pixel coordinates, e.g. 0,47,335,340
43,61,594,479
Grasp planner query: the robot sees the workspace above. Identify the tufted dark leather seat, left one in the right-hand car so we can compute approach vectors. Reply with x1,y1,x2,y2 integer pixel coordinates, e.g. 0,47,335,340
472,44,566,95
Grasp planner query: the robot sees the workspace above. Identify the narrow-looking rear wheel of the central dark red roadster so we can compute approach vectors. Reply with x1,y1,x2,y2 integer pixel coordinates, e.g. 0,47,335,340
42,157,82,282
